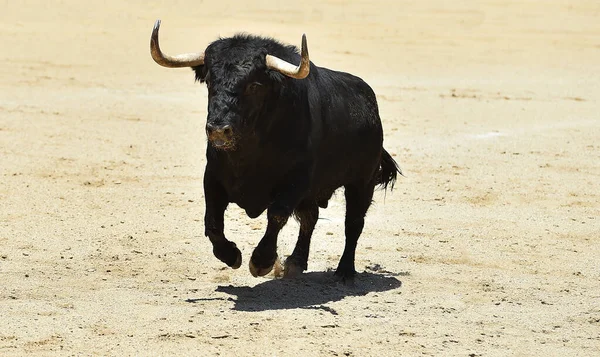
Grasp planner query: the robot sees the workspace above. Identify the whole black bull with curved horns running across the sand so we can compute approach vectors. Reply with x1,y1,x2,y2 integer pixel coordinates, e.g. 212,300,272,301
151,21,401,280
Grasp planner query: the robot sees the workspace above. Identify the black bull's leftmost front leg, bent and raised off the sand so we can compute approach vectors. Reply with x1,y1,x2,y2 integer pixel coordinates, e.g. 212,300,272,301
204,170,242,269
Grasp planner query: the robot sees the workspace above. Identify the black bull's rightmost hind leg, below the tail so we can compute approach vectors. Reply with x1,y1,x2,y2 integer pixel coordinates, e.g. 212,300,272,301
335,182,375,282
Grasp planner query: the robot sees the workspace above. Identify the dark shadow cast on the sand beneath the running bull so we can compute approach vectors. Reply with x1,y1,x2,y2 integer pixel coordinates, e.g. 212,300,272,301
209,272,402,315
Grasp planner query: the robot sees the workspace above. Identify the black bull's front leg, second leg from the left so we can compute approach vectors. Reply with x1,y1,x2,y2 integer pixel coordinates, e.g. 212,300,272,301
250,176,308,277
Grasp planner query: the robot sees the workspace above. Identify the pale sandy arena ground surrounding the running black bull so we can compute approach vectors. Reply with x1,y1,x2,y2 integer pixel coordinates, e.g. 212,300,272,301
0,0,600,356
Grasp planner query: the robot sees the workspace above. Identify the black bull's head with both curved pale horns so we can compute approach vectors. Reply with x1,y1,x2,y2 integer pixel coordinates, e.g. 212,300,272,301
150,20,310,150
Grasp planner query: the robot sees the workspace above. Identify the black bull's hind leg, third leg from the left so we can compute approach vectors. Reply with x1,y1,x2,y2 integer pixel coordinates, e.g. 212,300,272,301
283,203,319,278
